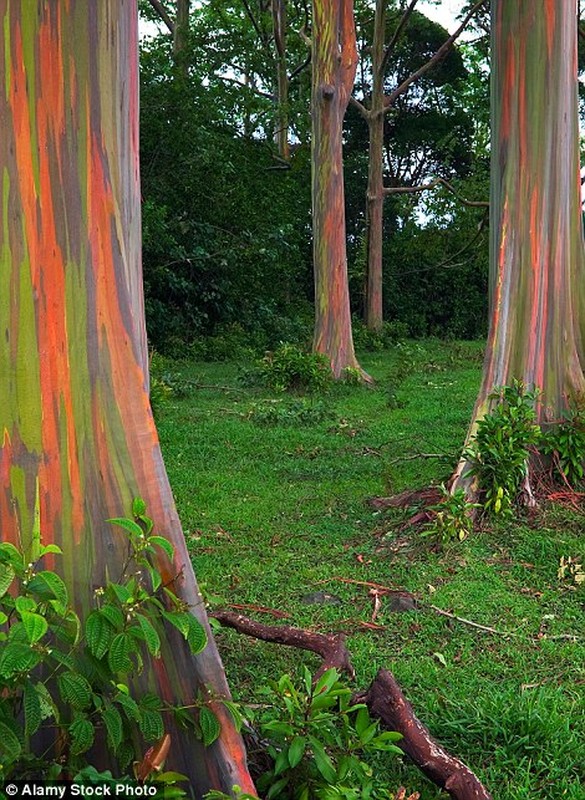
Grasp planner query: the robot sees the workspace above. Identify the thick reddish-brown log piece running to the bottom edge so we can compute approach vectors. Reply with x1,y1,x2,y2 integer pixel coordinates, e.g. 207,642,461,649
357,670,491,800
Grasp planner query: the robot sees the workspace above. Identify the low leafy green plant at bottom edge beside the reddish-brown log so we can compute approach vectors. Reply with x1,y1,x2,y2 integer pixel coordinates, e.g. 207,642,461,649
245,668,402,800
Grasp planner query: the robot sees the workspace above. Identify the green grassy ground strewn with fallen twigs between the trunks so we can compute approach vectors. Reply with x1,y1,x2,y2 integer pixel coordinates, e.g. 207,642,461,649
158,341,585,800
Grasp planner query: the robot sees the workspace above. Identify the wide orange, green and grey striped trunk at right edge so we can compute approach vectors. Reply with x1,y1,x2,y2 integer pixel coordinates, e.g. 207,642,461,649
454,0,585,488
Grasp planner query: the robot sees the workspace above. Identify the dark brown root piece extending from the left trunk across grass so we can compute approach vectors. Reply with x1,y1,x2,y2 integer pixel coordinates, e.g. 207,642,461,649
209,611,355,678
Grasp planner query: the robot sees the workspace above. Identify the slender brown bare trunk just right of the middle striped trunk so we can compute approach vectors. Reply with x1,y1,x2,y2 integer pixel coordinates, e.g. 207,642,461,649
365,0,386,331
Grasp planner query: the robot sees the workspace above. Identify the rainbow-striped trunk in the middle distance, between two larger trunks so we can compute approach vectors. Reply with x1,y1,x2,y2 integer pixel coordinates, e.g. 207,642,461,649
311,0,368,380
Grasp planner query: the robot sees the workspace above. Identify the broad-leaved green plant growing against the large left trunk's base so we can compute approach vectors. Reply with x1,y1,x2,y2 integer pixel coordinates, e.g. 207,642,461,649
0,498,219,783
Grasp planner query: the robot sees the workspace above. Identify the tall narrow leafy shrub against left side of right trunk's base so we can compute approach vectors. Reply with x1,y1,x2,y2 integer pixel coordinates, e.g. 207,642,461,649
466,380,541,515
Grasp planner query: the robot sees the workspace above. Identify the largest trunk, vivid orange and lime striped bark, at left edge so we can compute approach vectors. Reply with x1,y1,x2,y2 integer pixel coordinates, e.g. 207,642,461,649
0,0,253,797
